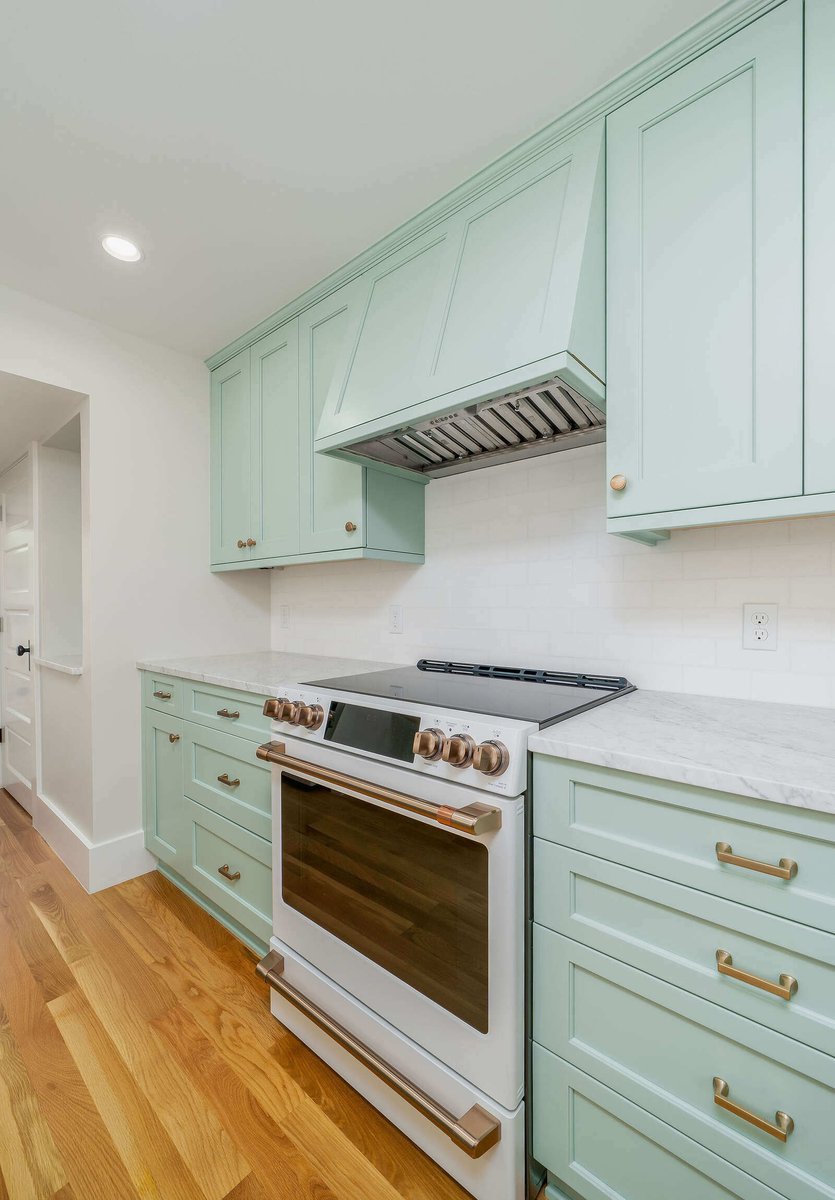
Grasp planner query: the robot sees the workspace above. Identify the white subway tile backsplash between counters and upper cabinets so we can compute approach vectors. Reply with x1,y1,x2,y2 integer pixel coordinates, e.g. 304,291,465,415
272,445,835,704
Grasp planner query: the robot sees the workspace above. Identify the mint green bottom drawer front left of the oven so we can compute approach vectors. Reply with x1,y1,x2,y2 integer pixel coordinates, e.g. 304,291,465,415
186,799,272,942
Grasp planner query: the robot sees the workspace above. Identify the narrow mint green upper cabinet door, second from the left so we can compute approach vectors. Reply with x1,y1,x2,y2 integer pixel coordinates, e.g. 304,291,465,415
247,320,299,559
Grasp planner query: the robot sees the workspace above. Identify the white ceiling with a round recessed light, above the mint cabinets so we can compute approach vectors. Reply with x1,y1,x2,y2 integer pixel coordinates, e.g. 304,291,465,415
0,0,717,356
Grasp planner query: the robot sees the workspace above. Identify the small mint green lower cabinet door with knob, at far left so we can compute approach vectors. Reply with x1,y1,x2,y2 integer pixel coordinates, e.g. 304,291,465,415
143,708,186,869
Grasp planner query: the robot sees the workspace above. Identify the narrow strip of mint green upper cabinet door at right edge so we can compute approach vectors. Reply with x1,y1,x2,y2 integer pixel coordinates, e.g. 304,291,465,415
805,0,835,493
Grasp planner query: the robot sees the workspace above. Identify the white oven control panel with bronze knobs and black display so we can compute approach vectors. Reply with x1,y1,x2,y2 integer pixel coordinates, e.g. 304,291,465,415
264,688,535,796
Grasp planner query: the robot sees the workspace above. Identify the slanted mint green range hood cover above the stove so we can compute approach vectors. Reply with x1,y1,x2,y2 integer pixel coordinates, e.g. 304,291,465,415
317,121,605,450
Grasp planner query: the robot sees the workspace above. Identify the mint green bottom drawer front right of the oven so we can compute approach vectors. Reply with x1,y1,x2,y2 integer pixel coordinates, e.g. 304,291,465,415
533,1044,779,1200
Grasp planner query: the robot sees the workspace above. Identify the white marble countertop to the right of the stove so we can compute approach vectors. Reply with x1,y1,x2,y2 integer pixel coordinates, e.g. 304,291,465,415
528,691,835,814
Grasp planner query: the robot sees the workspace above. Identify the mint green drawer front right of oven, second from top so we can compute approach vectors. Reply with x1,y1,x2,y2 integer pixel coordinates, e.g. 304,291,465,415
534,838,835,1055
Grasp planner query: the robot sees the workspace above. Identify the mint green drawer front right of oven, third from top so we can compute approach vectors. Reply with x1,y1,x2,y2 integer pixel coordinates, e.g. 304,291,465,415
534,926,835,1200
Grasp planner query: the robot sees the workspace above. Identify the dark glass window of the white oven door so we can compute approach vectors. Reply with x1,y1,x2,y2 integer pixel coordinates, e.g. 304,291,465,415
281,772,488,1033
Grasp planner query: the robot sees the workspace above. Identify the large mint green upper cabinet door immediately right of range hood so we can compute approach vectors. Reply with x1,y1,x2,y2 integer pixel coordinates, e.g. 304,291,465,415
607,0,801,523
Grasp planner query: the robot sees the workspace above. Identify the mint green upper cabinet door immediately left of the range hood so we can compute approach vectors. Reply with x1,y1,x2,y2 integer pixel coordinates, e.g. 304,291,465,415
299,284,365,551
